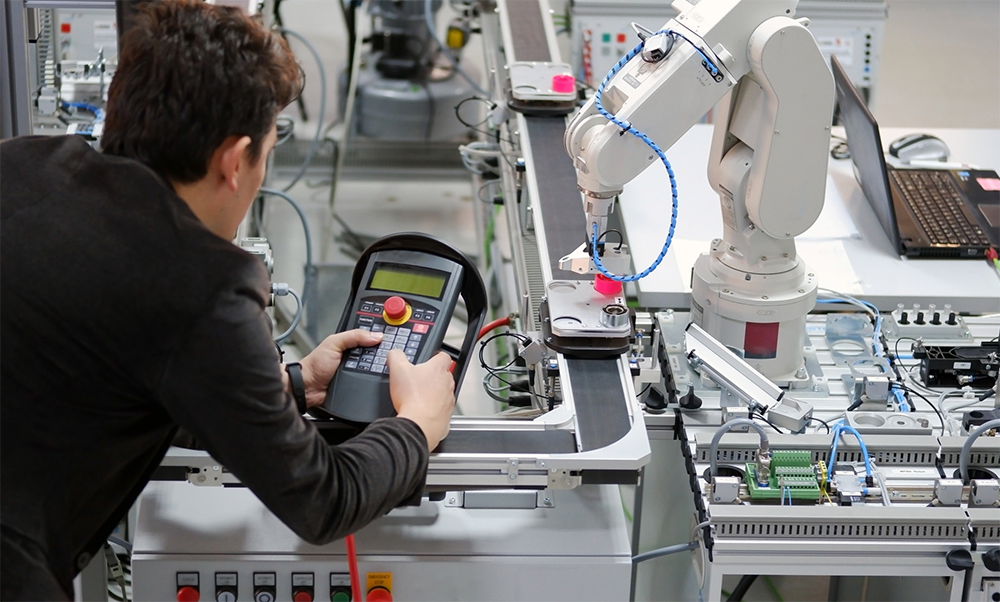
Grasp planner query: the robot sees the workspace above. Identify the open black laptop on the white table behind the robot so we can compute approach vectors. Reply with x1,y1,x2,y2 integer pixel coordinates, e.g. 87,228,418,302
830,56,1000,259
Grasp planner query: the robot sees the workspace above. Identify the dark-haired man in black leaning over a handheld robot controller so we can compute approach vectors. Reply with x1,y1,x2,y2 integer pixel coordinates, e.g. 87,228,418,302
0,0,454,602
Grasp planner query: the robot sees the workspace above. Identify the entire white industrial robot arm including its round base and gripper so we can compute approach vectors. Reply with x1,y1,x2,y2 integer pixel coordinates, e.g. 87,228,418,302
562,0,834,383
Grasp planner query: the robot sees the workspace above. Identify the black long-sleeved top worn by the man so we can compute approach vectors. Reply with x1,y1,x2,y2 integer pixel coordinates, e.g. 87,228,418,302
0,137,428,602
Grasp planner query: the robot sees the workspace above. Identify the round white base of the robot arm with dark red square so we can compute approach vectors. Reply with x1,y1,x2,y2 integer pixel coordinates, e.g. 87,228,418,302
691,248,818,389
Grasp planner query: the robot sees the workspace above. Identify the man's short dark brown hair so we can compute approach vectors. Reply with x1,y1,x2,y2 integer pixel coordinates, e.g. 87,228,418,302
101,0,301,183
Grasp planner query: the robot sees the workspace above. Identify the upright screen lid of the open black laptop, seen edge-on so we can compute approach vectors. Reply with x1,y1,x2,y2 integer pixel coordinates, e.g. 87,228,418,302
830,56,903,253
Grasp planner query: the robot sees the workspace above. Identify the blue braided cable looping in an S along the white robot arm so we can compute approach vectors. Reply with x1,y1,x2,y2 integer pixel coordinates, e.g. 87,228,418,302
590,29,719,282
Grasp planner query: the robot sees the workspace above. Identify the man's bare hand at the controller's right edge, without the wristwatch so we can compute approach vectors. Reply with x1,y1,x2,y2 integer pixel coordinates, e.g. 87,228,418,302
386,349,455,451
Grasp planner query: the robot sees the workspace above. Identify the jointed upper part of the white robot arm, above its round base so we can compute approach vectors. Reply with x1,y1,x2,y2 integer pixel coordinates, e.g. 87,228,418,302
565,0,833,278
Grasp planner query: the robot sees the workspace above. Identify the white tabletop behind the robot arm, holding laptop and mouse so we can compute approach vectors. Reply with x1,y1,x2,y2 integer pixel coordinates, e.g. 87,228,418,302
621,125,1000,313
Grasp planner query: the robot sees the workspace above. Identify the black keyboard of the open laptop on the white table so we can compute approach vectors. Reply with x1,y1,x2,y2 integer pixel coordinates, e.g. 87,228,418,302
889,169,990,247
